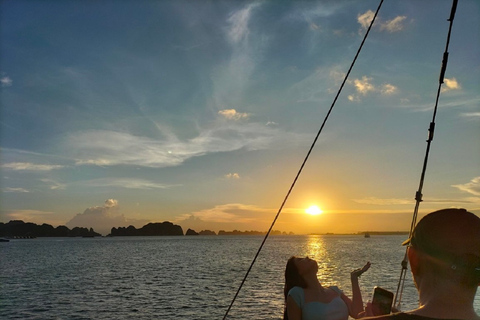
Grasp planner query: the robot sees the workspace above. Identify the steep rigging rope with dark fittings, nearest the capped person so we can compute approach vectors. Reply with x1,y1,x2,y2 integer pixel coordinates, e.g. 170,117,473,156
393,0,458,310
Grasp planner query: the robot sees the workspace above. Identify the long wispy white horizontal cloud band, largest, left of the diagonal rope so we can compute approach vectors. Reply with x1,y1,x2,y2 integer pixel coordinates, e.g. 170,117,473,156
63,121,311,168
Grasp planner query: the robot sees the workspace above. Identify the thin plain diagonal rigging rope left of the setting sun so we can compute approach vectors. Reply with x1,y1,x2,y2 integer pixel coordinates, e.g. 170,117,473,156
223,0,384,320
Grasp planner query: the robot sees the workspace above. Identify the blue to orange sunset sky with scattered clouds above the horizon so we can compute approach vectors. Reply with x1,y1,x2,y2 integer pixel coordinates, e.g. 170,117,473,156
0,0,480,235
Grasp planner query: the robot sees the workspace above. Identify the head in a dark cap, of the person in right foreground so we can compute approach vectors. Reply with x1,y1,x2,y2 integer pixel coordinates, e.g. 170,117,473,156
403,209,480,287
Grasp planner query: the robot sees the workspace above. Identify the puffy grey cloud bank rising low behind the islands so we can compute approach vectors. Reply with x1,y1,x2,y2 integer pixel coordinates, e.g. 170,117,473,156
66,199,148,235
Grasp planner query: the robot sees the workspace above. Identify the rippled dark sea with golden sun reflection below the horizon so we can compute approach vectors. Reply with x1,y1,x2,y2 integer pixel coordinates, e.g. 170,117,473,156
0,235,480,320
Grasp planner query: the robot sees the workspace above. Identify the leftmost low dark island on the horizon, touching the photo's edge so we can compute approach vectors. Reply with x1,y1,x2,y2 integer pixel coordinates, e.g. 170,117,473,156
0,220,102,239
